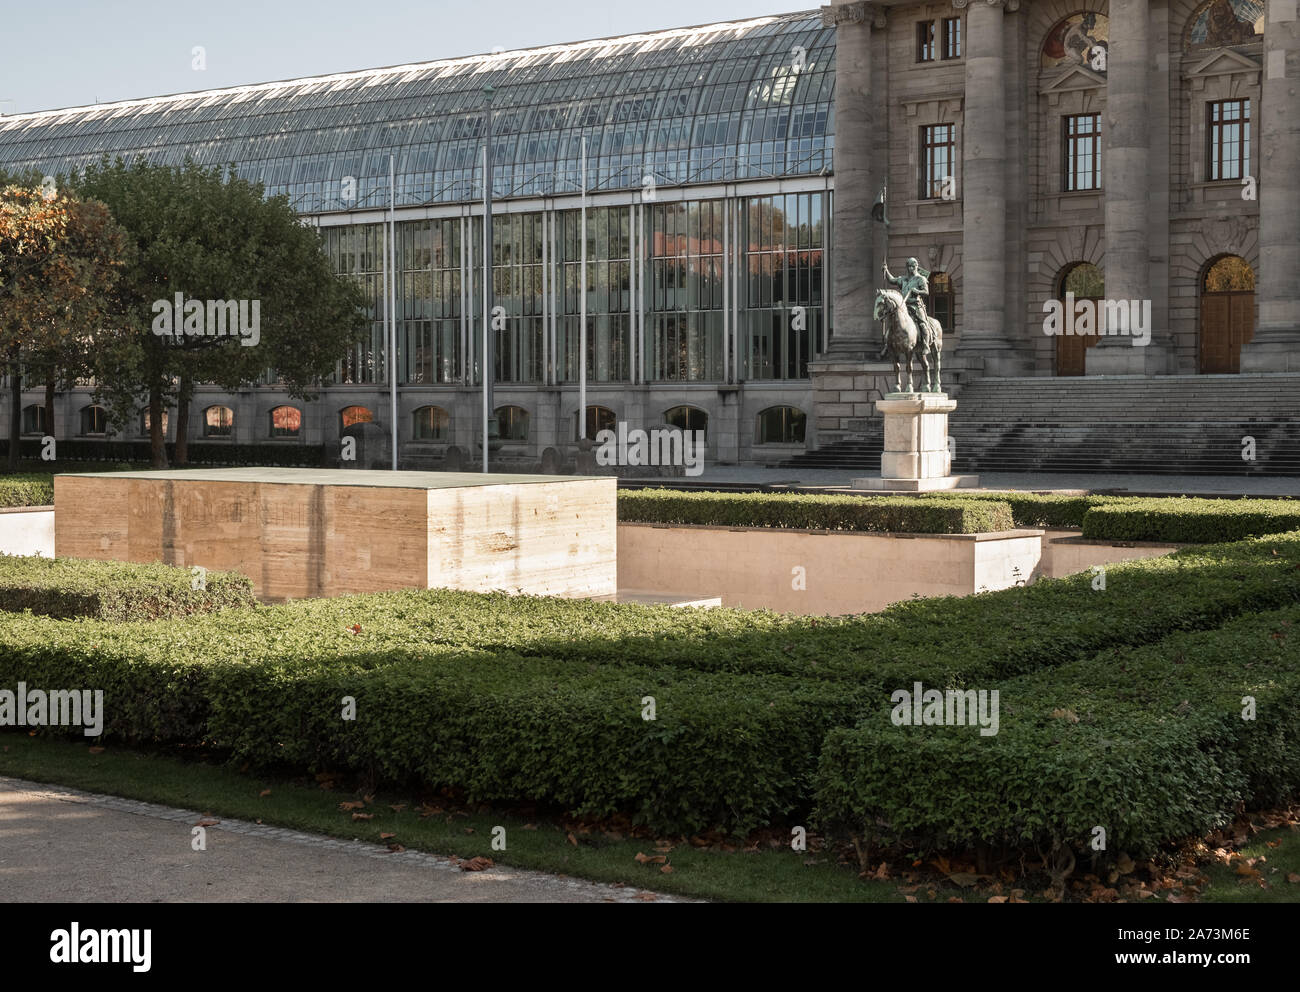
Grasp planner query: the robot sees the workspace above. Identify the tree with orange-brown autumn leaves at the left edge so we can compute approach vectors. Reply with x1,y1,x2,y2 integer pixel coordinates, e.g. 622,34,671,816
0,177,130,472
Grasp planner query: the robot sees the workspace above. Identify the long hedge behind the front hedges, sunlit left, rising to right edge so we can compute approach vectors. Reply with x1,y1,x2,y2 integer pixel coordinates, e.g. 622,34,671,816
266,533,1300,684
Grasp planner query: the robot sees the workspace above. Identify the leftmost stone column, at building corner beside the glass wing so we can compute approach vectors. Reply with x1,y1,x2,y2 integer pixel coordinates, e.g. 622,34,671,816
822,0,880,356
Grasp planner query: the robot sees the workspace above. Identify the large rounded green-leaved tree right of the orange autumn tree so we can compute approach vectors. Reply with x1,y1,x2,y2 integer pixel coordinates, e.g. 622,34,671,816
73,159,365,468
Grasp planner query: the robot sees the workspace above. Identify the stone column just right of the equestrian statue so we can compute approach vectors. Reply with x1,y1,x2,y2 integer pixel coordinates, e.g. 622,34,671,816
956,0,1019,376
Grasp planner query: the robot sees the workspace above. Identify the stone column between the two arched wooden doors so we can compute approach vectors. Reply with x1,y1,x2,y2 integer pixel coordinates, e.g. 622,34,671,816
1087,0,1169,376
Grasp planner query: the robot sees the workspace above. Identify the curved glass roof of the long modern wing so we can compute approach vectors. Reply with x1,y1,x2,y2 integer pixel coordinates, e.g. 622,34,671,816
0,10,835,213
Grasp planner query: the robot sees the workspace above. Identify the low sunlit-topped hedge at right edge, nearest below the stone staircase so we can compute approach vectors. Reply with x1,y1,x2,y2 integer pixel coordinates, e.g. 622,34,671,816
1083,497,1300,543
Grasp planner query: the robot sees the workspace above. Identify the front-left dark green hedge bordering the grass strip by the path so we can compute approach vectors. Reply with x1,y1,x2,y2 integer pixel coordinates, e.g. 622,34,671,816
0,621,865,833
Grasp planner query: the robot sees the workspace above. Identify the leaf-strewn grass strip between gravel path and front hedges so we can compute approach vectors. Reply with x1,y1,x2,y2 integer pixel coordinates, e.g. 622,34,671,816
0,733,1300,902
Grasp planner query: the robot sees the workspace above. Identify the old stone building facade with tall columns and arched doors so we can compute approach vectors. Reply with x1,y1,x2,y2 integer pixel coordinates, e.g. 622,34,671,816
813,0,1300,439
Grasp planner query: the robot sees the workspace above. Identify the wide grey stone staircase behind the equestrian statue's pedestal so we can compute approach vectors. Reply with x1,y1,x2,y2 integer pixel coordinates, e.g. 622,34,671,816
783,373,1300,478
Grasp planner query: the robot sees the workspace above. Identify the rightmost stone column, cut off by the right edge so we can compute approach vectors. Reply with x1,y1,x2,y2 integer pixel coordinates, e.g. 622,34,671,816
1242,0,1300,372
